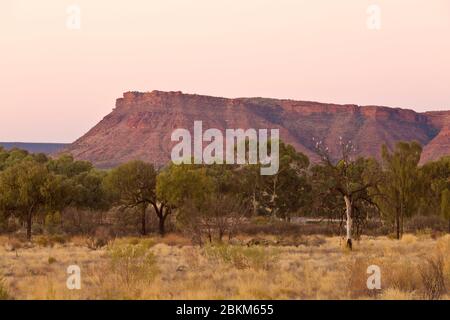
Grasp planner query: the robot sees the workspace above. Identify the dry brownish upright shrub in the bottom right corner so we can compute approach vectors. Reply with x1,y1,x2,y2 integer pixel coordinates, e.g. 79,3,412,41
420,255,446,300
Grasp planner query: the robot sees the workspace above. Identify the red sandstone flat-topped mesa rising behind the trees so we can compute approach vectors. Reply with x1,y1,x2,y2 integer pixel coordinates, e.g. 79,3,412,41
65,91,450,168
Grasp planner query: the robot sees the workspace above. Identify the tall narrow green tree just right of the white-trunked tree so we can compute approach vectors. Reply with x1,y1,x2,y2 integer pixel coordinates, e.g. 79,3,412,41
377,142,422,239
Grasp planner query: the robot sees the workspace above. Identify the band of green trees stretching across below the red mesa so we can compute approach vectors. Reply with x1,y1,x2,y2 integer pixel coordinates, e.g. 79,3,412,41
0,140,450,247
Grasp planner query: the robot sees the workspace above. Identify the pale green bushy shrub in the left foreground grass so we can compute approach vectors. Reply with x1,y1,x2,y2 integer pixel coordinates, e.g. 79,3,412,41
109,243,158,286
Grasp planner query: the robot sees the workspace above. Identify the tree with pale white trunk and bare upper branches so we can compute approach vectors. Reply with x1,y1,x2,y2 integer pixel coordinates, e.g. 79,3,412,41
313,138,380,249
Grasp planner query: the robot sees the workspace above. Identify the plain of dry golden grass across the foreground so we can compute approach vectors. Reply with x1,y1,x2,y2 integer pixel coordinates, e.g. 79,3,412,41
0,235,450,299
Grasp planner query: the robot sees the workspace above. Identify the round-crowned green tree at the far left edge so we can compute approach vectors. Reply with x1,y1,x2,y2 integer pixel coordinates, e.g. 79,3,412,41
0,160,56,240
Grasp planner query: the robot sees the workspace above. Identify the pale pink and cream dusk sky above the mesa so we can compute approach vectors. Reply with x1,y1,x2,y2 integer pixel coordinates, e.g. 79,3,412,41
0,0,450,142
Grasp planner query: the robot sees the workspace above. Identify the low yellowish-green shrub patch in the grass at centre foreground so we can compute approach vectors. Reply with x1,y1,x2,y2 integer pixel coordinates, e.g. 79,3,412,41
204,244,278,270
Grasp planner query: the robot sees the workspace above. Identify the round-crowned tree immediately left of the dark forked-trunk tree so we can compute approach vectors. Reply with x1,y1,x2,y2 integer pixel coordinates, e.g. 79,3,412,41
106,160,156,235
